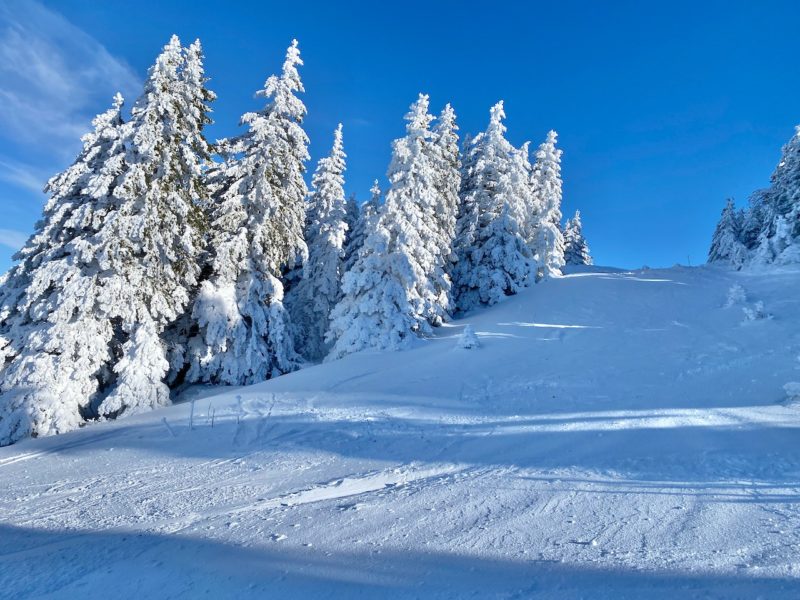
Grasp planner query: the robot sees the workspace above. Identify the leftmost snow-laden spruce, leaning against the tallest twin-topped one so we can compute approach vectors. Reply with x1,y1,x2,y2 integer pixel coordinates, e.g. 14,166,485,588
0,94,125,446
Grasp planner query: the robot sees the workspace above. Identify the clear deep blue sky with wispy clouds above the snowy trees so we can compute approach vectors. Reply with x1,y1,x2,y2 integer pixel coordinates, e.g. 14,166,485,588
0,0,800,269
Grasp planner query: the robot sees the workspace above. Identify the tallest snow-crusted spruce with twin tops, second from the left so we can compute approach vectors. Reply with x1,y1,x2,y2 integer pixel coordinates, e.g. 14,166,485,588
97,36,214,416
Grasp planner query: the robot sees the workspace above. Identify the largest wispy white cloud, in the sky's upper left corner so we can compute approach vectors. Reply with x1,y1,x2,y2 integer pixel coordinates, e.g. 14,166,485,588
0,0,139,152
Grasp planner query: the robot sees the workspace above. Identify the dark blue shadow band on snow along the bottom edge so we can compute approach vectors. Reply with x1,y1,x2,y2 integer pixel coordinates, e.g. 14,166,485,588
0,526,798,600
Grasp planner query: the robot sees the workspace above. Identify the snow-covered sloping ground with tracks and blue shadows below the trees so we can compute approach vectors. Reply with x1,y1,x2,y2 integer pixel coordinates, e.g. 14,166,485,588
0,268,800,599
